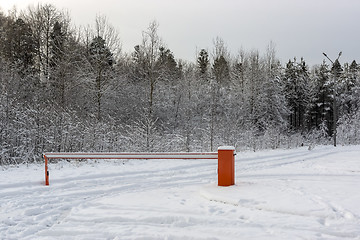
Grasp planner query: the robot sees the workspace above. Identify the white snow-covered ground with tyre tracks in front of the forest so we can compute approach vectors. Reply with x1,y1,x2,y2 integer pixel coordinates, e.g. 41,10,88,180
0,146,360,240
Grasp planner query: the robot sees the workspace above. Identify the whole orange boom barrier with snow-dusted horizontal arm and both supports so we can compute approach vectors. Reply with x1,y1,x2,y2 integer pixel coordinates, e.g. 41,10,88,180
43,147,235,186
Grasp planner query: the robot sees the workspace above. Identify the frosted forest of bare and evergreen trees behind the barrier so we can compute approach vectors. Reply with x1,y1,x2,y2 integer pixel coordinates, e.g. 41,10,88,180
0,4,360,165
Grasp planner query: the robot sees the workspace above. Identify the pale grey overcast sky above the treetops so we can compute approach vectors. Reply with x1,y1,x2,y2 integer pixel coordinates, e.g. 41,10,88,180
0,0,360,65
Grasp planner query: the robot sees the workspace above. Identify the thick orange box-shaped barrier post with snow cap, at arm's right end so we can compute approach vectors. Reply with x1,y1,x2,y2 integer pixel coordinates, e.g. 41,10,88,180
218,146,235,187
